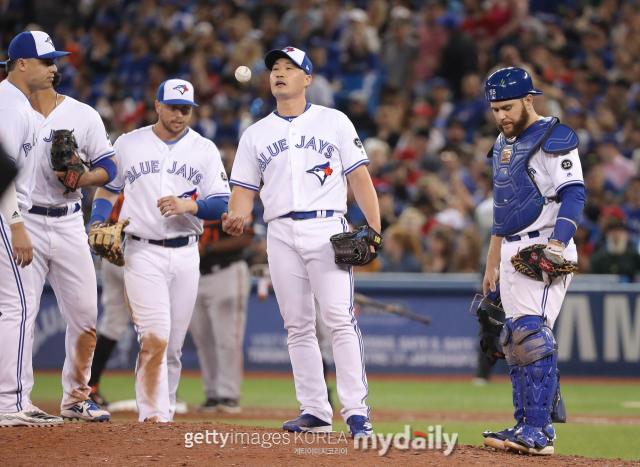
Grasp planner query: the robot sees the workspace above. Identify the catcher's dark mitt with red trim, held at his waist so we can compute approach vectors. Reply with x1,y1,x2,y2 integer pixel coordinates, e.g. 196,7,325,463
511,244,578,282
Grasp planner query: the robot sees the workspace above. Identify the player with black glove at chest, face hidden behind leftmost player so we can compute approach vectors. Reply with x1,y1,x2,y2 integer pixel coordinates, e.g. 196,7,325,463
24,65,117,422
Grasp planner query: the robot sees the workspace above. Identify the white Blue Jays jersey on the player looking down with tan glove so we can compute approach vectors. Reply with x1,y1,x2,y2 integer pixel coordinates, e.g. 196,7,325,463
105,126,230,240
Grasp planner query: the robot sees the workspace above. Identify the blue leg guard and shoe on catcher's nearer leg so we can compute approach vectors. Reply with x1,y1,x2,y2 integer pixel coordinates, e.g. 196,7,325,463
501,316,558,455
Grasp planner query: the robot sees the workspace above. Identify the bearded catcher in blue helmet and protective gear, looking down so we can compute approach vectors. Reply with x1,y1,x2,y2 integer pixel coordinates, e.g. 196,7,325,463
483,68,585,454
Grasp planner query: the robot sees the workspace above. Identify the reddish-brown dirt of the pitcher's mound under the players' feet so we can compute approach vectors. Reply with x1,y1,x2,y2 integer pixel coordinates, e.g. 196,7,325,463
0,422,640,467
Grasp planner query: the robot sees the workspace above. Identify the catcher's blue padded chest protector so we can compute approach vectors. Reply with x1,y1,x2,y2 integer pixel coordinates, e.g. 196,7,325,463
492,117,559,237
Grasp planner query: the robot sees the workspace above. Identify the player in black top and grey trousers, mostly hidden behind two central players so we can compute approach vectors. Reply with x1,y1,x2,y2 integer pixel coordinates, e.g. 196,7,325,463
190,215,253,413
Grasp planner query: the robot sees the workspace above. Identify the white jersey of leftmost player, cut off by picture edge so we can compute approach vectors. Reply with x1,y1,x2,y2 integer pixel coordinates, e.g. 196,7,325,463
0,79,36,210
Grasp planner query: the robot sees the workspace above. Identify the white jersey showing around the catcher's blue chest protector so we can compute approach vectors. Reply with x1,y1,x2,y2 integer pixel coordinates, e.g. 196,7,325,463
510,121,584,238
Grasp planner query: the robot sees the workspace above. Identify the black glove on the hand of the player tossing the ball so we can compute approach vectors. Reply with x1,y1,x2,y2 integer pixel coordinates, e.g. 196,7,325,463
330,225,382,266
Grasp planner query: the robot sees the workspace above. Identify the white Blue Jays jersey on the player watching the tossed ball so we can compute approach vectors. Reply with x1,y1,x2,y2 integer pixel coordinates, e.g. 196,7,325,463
230,105,369,222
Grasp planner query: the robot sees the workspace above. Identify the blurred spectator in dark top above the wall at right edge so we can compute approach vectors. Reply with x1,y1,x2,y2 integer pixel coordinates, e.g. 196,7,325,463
591,220,640,282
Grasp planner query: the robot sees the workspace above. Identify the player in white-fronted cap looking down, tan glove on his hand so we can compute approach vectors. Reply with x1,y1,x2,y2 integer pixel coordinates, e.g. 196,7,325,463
91,79,229,422
